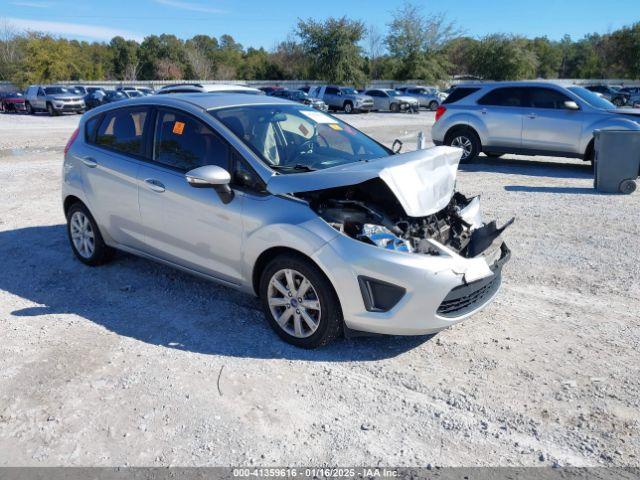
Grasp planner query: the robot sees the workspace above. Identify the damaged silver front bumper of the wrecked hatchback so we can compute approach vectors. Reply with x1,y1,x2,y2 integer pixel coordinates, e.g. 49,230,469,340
314,235,510,335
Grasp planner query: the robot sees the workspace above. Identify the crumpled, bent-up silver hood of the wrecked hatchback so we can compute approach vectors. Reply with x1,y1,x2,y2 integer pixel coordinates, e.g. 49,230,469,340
267,147,462,217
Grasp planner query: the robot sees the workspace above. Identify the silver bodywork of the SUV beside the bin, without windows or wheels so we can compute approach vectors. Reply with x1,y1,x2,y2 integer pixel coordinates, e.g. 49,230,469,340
431,82,640,158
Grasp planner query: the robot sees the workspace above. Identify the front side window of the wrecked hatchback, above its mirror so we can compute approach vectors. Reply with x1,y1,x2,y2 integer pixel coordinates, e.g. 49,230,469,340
154,111,229,172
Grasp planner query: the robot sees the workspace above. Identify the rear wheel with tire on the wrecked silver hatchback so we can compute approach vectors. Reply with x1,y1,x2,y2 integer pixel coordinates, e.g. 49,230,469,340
67,203,113,267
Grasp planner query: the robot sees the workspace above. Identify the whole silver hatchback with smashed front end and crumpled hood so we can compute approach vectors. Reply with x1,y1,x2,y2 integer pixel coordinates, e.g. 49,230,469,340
62,93,509,348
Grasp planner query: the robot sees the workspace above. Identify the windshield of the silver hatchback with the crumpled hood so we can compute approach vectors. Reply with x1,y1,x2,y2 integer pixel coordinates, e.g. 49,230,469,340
210,105,392,173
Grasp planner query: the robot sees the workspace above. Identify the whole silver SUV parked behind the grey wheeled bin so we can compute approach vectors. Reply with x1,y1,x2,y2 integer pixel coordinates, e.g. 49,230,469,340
431,82,640,162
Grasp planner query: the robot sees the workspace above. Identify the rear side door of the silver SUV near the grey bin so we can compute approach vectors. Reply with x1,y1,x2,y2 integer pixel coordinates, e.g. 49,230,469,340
478,87,527,148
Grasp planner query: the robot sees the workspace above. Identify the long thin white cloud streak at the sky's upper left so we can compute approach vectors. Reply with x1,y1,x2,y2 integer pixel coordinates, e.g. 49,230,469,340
3,17,143,40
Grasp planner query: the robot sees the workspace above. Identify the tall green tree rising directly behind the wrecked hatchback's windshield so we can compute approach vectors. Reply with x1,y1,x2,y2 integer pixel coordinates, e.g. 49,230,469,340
297,17,365,85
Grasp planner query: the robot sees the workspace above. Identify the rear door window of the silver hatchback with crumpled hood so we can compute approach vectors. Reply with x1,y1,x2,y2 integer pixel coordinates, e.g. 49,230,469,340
95,108,148,156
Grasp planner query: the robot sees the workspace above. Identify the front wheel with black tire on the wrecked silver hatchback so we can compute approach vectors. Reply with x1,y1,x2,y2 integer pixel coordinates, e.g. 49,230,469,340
259,254,342,349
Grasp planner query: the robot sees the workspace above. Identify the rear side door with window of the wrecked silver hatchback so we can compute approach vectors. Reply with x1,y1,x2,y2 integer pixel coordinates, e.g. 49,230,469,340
78,106,150,249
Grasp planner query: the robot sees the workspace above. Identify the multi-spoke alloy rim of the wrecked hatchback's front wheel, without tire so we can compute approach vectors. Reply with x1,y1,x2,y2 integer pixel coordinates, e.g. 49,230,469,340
267,269,322,338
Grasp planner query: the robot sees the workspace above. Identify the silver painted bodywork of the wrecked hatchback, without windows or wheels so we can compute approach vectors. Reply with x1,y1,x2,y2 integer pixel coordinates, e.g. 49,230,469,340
62,94,499,335
